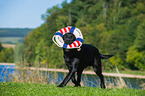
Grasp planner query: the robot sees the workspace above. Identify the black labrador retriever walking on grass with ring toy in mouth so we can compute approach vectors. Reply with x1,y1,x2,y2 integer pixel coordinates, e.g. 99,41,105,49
58,33,113,88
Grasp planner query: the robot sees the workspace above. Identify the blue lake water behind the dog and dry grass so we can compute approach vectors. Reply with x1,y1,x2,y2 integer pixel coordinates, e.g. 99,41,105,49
0,65,145,89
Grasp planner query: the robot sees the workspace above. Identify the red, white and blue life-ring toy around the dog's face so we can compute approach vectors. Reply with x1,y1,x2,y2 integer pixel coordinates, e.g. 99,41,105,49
52,26,84,49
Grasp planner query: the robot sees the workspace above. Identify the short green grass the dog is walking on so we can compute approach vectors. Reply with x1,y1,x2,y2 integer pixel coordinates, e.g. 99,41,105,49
0,82,145,96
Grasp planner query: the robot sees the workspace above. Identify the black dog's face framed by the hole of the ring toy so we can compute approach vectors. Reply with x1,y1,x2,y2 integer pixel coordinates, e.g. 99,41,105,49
63,33,76,44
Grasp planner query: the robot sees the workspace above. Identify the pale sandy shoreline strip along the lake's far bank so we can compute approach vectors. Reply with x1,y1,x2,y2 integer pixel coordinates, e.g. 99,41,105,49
0,63,145,79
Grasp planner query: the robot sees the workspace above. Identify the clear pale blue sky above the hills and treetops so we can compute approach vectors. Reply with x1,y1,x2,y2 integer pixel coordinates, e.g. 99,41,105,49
0,0,70,28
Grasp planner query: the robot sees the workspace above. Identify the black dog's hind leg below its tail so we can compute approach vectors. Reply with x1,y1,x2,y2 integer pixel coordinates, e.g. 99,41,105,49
93,58,105,89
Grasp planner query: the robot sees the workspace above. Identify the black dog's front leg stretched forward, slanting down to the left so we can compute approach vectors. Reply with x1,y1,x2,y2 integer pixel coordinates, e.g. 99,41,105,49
58,58,79,87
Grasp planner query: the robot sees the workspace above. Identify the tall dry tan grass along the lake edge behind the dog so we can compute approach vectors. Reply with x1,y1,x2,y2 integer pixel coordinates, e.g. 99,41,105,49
0,62,145,90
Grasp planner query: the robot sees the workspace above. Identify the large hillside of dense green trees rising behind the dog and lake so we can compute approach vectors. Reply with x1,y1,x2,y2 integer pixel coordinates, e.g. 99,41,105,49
21,0,145,70
